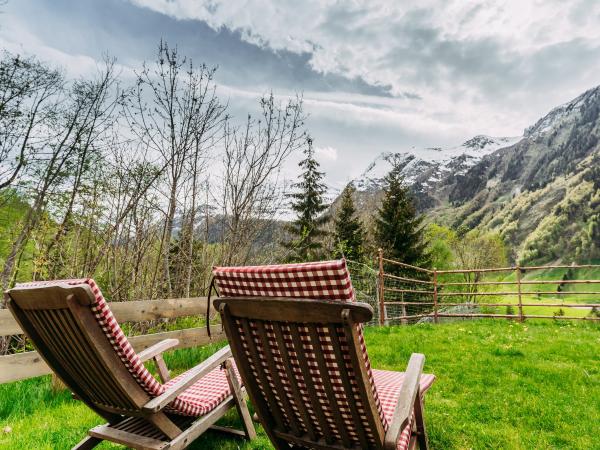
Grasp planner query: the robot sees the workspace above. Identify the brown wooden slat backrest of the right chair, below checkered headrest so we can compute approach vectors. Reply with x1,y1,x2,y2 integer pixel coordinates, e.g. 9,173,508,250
215,297,385,449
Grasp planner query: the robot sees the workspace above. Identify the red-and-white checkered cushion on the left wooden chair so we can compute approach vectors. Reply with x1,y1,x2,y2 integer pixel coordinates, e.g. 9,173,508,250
19,278,237,416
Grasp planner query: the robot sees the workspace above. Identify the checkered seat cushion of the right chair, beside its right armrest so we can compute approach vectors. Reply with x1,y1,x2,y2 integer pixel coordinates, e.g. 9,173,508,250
373,369,435,450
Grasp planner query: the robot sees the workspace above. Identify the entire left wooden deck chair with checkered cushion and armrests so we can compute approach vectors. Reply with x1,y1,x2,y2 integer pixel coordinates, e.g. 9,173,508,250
6,279,255,449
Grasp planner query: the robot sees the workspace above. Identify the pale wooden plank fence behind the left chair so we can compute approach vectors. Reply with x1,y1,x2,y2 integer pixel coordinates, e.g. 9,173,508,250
0,297,225,384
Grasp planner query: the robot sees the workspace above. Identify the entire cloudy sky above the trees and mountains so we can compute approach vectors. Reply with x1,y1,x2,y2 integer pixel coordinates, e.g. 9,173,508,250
0,0,600,191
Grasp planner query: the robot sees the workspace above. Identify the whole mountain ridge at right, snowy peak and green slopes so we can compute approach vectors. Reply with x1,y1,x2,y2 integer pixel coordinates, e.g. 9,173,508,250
334,86,600,262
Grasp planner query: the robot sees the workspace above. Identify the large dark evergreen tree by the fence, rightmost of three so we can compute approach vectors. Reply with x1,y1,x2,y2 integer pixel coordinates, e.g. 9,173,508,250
375,166,431,277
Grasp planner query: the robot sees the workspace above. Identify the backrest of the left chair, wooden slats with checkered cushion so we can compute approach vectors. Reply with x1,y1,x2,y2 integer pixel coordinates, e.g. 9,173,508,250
6,279,164,417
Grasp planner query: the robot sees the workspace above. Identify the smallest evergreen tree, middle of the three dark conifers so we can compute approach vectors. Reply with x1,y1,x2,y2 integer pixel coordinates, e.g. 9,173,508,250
333,183,365,261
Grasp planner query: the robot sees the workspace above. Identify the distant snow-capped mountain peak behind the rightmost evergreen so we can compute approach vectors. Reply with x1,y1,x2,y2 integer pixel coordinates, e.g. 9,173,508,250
354,135,522,192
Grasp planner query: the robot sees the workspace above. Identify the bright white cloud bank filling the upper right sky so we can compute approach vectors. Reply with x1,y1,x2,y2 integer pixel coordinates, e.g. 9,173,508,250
130,0,600,137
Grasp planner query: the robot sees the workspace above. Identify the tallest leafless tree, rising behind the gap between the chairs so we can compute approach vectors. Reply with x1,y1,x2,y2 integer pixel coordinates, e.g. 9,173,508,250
126,42,226,295
